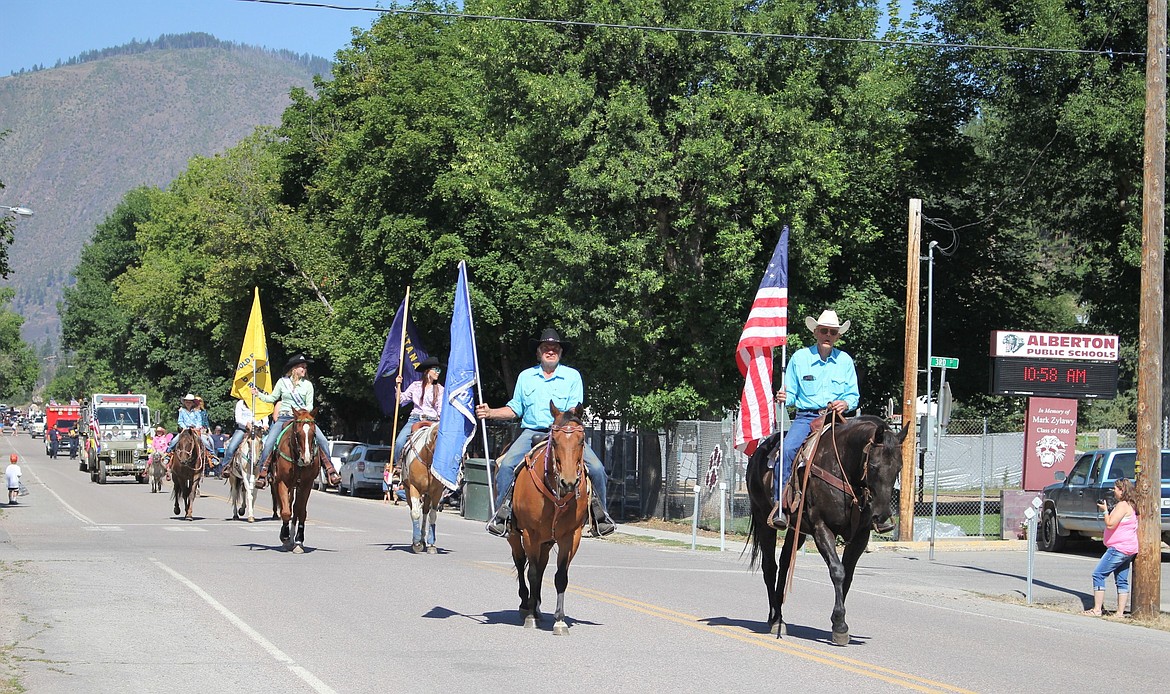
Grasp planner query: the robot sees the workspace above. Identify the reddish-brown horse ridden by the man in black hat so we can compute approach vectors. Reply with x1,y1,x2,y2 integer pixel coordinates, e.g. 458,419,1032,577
508,403,591,635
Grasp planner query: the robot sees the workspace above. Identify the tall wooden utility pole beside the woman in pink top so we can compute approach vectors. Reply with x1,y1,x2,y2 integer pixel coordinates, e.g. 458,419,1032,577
1133,0,1166,619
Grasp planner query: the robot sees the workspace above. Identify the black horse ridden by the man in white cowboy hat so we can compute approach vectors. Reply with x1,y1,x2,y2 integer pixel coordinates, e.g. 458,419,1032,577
746,415,909,646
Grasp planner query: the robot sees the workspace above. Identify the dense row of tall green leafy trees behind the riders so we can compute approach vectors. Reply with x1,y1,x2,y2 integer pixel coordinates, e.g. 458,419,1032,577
52,0,1144,431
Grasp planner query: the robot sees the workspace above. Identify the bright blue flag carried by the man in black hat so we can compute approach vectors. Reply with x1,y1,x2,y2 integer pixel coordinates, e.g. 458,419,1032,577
431,261,479,489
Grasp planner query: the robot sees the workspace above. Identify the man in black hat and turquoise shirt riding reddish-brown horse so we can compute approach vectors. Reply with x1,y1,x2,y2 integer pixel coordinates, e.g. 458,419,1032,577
475,328,615,537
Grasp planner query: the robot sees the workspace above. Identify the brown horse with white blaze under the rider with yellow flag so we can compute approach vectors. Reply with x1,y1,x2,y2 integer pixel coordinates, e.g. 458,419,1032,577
273,408,321,554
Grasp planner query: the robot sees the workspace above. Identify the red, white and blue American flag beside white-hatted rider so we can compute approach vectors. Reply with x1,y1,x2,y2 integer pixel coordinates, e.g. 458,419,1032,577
735,226,789,455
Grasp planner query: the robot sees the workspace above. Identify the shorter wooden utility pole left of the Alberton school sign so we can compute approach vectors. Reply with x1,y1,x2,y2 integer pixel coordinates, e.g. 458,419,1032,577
897,198,922,542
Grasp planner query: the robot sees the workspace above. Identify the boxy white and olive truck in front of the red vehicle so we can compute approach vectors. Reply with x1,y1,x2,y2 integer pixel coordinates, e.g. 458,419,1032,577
80,393,151,485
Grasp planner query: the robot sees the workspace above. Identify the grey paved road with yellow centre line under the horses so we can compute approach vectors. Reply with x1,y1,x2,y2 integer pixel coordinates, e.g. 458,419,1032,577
0,437,1170,694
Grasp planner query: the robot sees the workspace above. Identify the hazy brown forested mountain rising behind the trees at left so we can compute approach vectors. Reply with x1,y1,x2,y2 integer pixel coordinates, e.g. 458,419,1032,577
0,34,330,345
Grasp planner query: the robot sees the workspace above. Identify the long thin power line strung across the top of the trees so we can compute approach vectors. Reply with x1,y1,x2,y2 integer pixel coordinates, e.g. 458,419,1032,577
238,0,1145,57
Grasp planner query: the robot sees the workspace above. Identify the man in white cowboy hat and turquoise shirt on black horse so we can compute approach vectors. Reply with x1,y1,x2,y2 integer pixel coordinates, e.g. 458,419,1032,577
769,309,861,528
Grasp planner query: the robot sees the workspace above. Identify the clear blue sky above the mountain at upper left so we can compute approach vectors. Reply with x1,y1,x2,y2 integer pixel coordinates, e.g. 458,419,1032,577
0,0,386,76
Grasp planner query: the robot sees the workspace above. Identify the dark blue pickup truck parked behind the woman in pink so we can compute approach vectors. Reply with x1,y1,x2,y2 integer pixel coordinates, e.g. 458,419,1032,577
1035,448,1170,552
